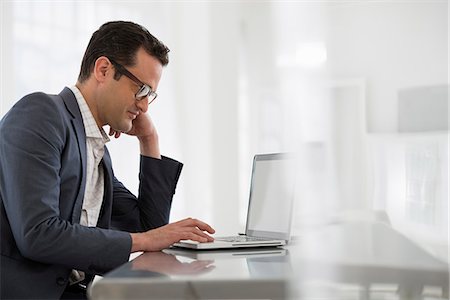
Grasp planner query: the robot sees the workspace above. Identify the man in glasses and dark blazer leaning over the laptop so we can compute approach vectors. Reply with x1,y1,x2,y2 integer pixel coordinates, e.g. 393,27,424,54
0,21,214,299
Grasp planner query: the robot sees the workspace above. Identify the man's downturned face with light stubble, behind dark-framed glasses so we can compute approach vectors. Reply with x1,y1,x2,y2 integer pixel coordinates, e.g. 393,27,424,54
98,49,162,132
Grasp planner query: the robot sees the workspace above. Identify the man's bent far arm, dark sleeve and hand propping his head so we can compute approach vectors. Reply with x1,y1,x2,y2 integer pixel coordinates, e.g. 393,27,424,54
109,112,183,232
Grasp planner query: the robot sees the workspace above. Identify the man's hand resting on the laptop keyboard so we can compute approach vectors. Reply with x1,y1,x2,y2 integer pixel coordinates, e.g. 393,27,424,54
131,218,215,252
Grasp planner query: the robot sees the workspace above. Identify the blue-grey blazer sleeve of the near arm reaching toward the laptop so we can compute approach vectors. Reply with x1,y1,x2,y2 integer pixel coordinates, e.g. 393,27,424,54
0,93,131,273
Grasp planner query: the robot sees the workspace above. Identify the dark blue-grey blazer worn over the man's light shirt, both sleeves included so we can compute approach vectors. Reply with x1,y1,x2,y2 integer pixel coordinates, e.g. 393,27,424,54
0,88,182,299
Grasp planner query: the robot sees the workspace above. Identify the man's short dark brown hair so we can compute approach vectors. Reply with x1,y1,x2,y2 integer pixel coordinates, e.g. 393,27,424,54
78,21,170,82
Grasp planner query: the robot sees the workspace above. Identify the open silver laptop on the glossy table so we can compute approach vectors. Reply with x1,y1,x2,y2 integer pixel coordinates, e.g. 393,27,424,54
173,153,295,250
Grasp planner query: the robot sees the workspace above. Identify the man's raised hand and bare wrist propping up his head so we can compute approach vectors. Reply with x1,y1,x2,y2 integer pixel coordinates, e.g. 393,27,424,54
109,112,161,159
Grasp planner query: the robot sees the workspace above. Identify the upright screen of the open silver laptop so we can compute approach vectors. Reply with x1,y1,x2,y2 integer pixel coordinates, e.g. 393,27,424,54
246,153,295,240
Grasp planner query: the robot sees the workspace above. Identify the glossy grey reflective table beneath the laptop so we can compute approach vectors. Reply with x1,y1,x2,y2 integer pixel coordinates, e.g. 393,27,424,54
91,222,449,300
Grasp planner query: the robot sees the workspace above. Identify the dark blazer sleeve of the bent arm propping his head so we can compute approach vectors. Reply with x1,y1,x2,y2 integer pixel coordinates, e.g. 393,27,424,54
111,155,183,232
